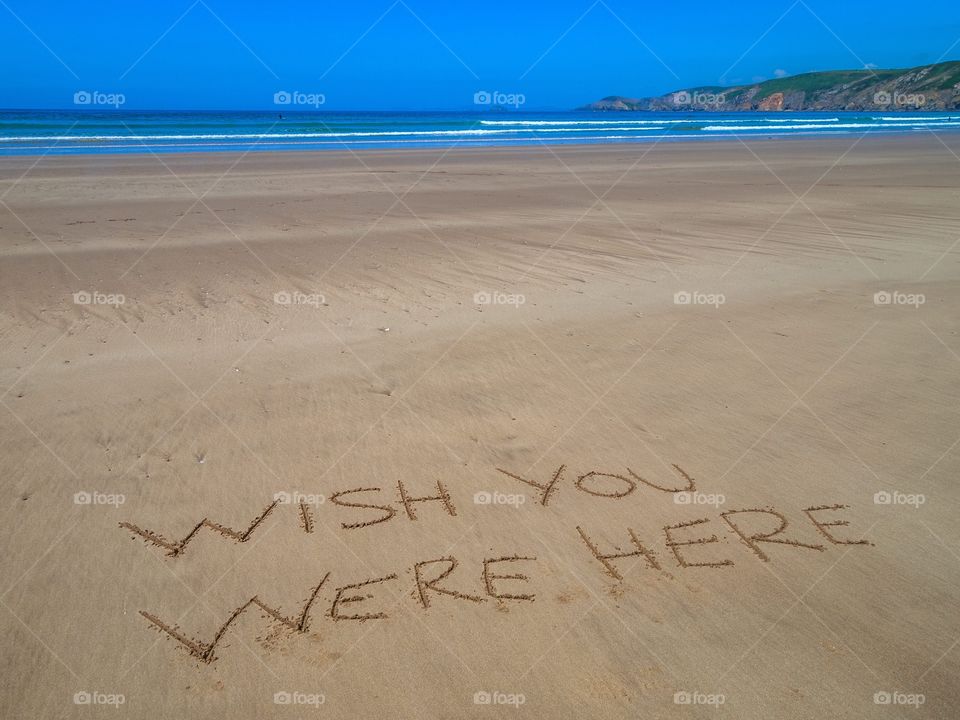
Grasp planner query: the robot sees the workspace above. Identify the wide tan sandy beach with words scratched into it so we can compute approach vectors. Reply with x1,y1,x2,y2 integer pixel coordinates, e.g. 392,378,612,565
0,135,960,720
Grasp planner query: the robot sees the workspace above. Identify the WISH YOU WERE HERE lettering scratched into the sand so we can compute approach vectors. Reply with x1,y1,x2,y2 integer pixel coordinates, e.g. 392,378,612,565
120,458,872,662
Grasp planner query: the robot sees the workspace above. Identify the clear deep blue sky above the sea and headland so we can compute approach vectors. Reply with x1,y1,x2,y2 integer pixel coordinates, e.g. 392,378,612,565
0,0,960,110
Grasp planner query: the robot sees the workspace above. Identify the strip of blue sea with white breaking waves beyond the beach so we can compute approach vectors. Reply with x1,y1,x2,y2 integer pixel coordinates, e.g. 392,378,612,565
0,109,960,155
